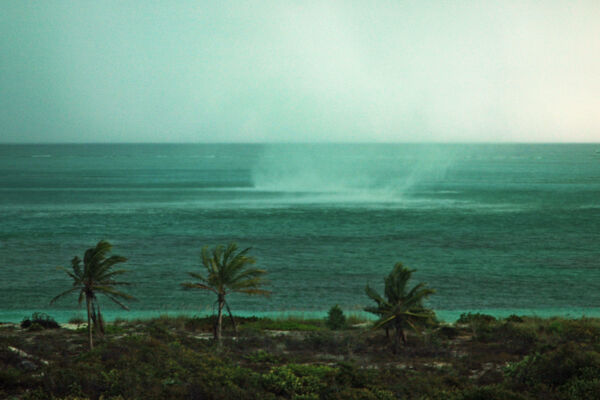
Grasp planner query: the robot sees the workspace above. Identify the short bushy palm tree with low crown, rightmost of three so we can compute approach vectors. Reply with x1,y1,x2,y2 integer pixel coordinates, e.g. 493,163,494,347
365,263,435,352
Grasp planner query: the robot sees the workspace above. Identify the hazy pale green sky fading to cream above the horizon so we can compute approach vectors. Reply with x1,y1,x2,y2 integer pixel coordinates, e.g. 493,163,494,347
0,0,600,143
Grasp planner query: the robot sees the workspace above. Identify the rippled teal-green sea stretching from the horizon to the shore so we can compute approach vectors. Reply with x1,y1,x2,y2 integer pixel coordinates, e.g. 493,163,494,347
0,144,600,321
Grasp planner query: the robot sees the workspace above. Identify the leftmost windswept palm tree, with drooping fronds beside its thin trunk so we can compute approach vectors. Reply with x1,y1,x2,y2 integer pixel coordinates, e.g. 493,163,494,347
50,240,133,350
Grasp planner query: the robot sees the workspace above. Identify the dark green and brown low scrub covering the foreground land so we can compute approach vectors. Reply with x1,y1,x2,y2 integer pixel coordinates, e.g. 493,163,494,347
0,312,600,400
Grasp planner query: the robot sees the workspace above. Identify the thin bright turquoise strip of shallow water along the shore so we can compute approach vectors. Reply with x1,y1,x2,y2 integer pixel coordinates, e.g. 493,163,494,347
0,308,600,324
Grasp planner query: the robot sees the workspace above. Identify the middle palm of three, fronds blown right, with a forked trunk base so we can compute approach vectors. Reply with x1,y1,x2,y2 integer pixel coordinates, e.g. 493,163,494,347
182,243,271,342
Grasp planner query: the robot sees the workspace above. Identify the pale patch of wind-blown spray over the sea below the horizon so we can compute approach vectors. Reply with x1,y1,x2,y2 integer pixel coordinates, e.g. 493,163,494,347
252,144,456,203
